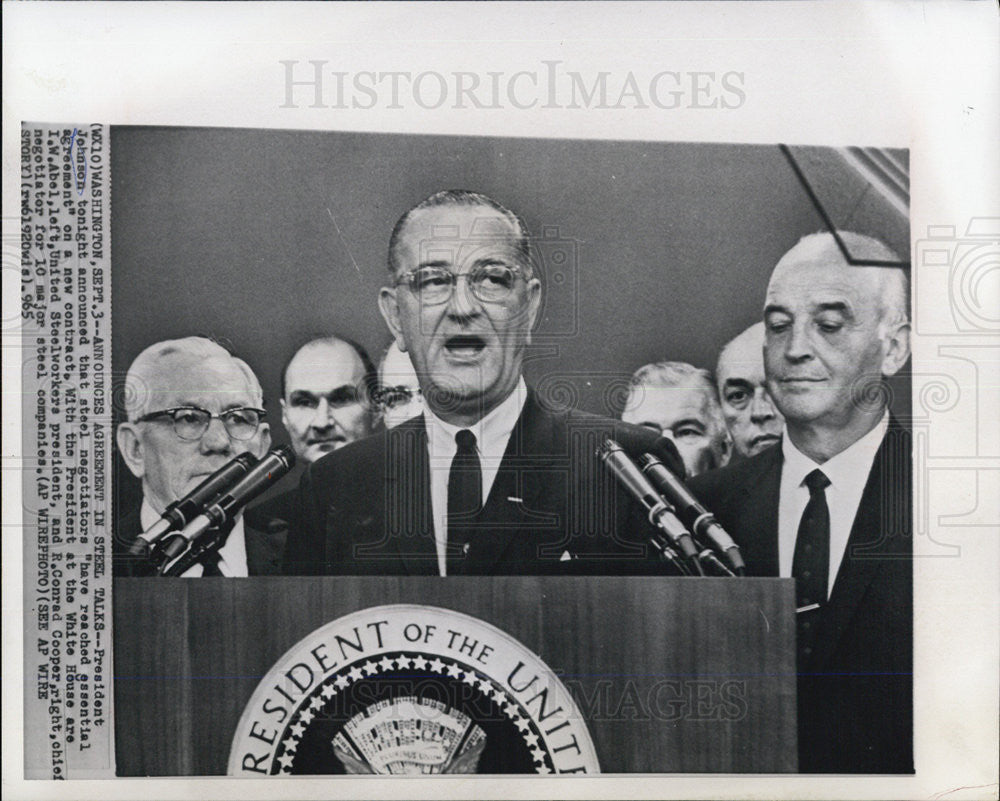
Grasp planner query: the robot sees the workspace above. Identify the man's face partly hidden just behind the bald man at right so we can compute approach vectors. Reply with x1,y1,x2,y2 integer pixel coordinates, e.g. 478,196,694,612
715,323,785,457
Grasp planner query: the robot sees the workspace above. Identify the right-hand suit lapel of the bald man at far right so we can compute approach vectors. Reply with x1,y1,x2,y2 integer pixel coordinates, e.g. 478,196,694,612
809,421,911,670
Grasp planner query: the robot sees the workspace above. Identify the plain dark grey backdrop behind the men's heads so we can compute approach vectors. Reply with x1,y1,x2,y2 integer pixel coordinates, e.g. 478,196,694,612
111,127,910,512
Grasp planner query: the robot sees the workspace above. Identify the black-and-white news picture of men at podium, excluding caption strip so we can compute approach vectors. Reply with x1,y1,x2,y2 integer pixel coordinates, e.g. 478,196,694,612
97,127,912,775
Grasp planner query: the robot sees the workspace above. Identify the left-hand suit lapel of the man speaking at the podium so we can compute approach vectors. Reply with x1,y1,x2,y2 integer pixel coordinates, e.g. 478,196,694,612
380,415,438,576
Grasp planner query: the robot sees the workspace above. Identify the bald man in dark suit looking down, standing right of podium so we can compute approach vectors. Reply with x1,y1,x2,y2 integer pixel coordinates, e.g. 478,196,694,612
691,232,913,773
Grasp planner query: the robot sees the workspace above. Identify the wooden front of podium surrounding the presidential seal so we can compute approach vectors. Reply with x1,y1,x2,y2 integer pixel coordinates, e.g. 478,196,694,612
113,577,797,776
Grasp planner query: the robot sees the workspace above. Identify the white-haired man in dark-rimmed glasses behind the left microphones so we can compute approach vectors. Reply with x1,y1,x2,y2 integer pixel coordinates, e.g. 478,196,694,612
112,337,284,577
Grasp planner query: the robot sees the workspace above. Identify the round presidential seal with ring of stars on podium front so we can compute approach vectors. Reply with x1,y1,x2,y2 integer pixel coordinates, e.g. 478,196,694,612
229,605,599,777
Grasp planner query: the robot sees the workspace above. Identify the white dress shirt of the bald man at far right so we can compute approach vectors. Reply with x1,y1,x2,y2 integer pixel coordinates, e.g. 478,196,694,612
778,412,889,598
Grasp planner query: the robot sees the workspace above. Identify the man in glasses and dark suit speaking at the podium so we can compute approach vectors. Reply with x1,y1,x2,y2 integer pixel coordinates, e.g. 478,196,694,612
285,190,684,576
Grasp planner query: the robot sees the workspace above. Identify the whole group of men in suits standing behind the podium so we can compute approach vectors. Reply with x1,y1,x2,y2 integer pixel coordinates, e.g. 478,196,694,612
116,190,912,772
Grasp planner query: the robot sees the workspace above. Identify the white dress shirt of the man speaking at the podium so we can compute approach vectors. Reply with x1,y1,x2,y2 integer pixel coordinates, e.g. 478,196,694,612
424,378,528,576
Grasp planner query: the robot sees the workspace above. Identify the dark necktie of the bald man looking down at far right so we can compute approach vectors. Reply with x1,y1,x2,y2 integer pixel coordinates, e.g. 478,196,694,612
792,469,830,665
